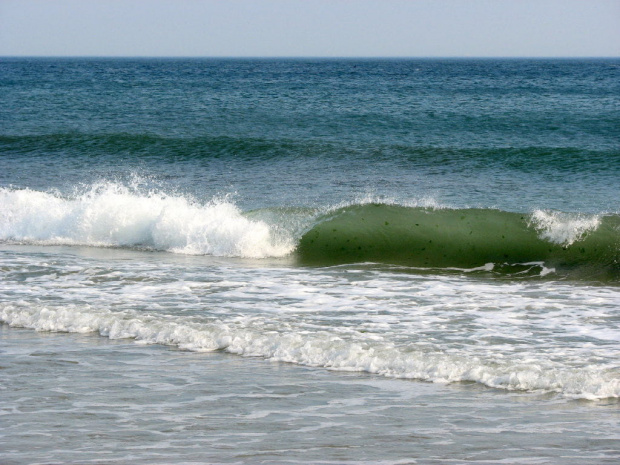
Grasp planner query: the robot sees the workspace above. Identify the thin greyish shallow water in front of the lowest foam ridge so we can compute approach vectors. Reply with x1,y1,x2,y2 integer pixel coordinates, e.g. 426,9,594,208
0,326,620,464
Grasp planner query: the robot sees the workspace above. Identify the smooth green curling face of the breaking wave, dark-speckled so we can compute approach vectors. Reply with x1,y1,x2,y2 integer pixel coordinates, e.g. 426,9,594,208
297,204,620,279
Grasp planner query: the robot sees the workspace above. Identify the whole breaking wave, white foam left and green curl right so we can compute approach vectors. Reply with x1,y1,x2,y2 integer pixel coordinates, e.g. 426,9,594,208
0,183,620,281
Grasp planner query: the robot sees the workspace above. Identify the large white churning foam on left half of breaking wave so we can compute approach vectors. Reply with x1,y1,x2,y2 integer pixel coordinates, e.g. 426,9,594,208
0,183,294,258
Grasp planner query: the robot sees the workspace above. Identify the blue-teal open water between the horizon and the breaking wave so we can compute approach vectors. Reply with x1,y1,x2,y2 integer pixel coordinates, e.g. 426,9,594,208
0,59,620,213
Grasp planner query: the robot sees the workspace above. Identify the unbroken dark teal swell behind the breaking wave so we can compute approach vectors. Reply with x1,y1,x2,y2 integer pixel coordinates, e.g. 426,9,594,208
0,132,620,169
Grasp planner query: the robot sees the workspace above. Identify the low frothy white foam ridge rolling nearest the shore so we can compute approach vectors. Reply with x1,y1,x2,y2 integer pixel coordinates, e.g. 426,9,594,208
0,302,620,400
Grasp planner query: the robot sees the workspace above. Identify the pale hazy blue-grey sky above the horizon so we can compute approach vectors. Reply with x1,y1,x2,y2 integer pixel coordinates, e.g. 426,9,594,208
0,0,620,57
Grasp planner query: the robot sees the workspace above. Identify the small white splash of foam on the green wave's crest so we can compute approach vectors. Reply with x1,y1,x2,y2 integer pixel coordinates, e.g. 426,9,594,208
531,210,601,246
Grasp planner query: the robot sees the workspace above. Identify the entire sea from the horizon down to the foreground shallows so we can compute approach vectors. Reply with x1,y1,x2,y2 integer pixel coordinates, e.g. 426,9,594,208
0,58,620,465
